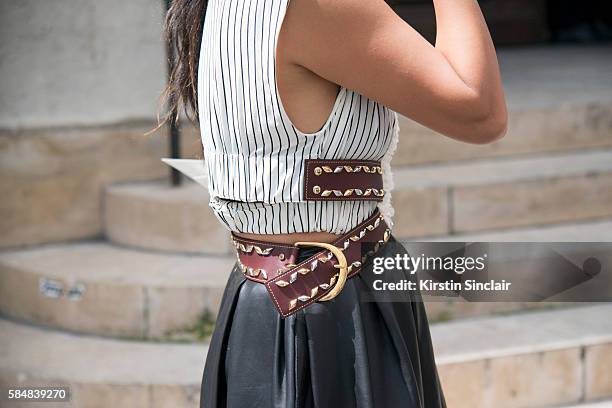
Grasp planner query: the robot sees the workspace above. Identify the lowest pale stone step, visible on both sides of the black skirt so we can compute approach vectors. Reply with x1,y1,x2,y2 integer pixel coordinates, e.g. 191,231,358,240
0,305,612,408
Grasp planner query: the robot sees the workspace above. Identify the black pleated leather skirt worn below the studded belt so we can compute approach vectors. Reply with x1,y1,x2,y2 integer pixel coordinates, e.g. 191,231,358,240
200,236,446,408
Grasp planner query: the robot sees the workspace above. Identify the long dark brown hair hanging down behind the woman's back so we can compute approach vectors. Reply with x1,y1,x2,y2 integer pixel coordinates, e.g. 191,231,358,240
154,0,208,130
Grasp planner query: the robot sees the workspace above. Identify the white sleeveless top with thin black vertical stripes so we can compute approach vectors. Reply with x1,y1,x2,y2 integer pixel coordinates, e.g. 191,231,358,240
197,0,399,234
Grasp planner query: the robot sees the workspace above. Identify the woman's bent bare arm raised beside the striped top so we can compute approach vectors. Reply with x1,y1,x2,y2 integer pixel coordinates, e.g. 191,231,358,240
286,0,507,143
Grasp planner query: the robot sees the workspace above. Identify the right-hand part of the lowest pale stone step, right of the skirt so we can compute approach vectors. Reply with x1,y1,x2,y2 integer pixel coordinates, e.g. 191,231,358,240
431,304,612,408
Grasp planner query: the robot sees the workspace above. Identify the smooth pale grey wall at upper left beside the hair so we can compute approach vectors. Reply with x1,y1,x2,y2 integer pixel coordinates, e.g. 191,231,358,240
0,0,166,128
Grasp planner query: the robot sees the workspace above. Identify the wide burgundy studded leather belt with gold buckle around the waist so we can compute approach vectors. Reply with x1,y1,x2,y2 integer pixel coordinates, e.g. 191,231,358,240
232,209,391,317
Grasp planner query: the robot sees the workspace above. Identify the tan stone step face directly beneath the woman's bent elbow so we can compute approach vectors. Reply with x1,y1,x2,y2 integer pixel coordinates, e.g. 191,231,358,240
391,102,612,167
